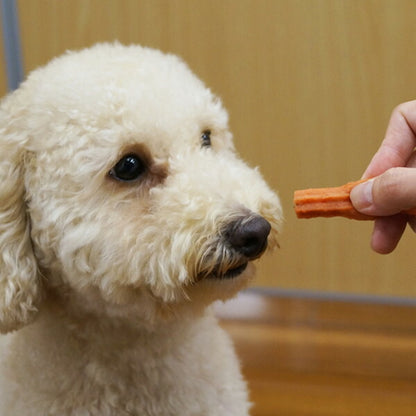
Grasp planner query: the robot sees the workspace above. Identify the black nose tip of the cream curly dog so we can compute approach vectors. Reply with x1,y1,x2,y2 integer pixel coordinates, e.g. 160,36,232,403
225,215,271,259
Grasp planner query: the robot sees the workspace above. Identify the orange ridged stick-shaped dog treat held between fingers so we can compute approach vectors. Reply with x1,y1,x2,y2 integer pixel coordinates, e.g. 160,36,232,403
294,179,416,220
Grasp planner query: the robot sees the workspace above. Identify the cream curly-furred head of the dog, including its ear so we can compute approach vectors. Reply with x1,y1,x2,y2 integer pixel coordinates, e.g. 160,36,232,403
0,45,281,331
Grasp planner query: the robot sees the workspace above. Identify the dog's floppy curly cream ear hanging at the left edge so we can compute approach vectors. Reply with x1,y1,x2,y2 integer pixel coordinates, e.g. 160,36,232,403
0,92,42,333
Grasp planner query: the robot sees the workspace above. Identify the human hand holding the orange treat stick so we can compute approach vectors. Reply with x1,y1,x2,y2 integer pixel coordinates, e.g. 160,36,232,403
350,100,416,254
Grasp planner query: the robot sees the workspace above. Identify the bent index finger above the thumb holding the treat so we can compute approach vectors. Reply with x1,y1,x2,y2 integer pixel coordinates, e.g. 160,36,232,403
363,100,416,178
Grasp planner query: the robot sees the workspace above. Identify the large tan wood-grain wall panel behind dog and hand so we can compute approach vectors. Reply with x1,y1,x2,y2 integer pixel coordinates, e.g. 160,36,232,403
13,0,416,296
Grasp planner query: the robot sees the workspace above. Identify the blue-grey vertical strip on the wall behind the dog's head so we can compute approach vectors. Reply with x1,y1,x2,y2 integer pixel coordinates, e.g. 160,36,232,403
0,0,23,91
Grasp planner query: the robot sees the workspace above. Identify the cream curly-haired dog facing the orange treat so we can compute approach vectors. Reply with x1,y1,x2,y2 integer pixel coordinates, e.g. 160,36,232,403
0,44,281,416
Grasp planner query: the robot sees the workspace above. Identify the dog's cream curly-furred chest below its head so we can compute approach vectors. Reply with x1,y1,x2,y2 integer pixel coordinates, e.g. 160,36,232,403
0,319,248,416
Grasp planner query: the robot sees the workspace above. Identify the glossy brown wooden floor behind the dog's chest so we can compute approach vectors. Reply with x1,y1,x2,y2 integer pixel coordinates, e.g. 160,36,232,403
217,291,416,416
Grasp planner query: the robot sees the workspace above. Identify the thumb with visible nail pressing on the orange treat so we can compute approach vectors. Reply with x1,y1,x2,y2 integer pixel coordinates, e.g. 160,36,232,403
350,168,416,216
